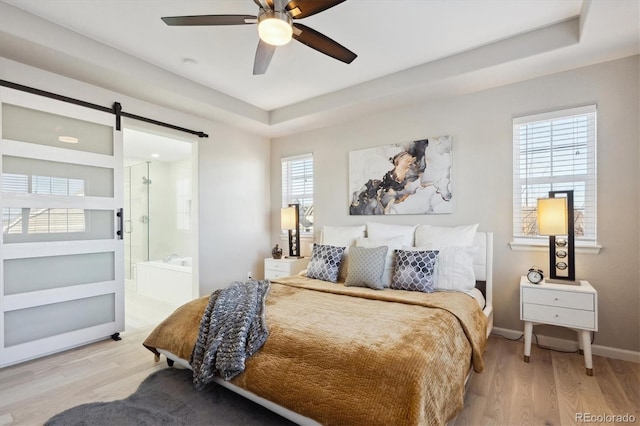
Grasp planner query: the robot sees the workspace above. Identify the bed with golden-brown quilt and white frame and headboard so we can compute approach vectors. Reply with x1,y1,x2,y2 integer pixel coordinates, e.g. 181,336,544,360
144,224,493,425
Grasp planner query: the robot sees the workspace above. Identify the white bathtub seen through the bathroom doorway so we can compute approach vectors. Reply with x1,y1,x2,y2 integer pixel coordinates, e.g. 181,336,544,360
136,257,194,307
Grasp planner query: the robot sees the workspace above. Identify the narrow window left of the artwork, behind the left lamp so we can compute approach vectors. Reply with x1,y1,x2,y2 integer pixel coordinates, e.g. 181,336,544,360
282,154,313,233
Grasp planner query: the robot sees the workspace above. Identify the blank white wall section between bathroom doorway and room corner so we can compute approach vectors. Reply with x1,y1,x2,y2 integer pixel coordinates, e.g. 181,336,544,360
199,127,272,294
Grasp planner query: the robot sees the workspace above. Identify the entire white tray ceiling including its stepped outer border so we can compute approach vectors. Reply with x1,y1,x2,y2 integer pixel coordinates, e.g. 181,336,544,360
0,0,640,136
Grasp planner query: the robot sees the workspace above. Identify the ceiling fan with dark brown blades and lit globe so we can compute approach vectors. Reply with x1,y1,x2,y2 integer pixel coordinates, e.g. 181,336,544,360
162,0,358,75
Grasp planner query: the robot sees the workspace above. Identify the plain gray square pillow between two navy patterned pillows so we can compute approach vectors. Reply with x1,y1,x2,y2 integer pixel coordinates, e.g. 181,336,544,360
344,246,389,290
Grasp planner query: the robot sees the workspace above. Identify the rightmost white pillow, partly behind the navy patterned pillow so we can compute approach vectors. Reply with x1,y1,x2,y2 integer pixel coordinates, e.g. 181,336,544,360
403,244,478,292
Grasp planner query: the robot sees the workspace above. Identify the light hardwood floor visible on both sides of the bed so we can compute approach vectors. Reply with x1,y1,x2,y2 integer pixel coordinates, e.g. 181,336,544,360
0,309,640,425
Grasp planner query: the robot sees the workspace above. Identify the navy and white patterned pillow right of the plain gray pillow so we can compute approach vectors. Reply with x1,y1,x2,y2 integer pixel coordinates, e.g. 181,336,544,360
391,250,438,293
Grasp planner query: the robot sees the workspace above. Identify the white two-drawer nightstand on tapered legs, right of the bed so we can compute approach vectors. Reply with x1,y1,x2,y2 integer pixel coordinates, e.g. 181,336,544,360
520,277,598,376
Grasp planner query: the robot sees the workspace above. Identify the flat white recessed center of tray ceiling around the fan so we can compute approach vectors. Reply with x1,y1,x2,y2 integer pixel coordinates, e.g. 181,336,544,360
4,0,582,110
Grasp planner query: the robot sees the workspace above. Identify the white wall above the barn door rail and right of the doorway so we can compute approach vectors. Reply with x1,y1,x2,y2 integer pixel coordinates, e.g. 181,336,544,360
0,57,270,295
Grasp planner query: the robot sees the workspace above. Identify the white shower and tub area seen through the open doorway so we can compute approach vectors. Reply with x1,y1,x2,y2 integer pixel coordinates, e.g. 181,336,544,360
124,155,193,303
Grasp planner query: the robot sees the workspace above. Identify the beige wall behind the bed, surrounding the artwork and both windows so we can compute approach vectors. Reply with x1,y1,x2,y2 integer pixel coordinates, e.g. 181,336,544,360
271,56,640,351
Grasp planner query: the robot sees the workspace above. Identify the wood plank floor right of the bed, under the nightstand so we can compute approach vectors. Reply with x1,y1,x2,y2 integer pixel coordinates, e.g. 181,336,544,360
456,336,640,425
